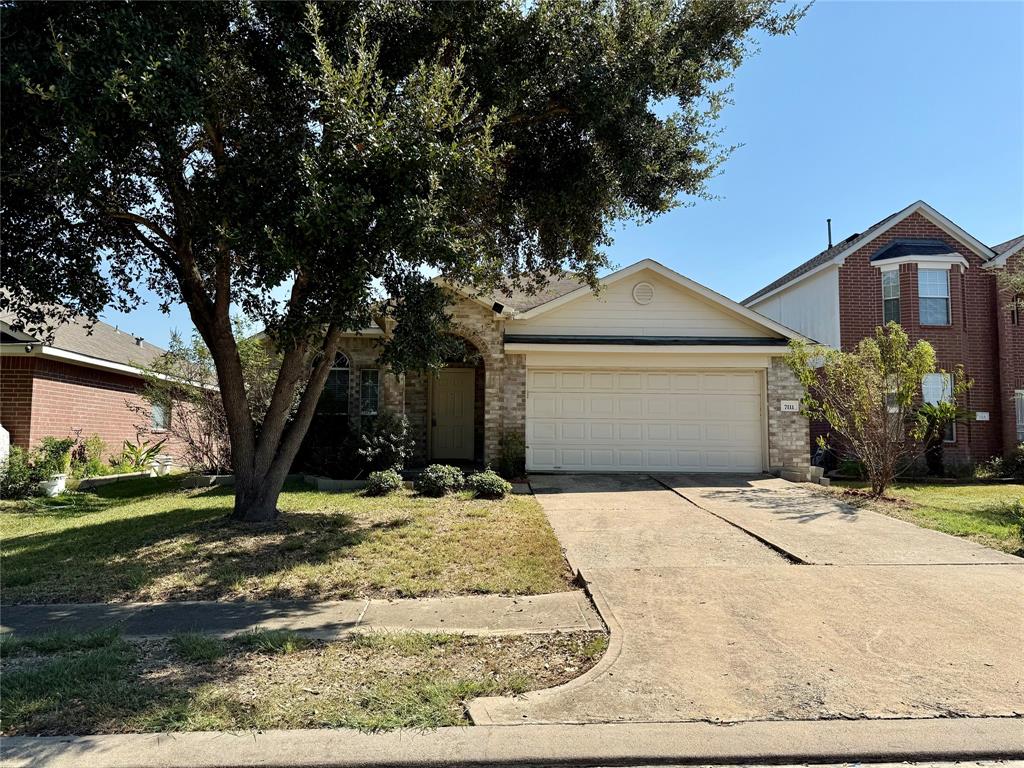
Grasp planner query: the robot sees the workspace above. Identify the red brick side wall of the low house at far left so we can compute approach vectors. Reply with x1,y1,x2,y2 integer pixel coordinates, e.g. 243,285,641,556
0,356,184,455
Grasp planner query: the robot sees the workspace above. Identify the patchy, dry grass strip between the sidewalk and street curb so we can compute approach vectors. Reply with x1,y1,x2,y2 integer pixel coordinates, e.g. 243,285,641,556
0,632,607,735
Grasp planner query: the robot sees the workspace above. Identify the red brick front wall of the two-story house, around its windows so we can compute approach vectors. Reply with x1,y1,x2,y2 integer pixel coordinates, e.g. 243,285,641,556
839,213,999,462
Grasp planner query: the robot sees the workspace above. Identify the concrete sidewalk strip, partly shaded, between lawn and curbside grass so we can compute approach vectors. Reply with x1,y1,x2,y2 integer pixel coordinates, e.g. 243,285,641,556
0,591,604,640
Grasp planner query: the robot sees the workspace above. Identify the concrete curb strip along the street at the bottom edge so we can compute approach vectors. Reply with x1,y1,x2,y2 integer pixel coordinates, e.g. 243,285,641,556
0,718,1024,768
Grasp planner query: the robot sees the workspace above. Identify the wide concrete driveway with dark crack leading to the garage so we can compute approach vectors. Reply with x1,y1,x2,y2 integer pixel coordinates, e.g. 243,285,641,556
470,475,1024,735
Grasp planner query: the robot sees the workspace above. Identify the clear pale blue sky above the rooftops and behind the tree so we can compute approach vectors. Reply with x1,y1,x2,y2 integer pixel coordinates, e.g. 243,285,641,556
104,0,1024,345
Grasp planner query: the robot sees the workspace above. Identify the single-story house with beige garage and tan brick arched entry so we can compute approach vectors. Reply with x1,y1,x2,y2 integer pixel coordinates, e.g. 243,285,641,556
322,259,809,476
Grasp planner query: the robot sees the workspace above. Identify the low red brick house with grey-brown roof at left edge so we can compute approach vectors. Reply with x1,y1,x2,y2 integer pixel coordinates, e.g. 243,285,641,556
0,314,175,456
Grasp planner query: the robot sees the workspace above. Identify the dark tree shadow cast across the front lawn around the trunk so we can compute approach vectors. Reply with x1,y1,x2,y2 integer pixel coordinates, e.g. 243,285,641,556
2,478,411,603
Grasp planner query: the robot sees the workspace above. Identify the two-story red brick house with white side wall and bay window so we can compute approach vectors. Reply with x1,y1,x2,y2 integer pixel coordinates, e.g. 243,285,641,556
741,201,1024,462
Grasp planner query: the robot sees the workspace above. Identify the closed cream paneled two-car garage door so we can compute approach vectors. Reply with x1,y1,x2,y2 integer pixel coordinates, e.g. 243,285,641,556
526,369,764,472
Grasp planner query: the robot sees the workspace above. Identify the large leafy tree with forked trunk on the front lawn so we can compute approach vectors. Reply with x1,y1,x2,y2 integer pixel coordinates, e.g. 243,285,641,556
0,0,802,520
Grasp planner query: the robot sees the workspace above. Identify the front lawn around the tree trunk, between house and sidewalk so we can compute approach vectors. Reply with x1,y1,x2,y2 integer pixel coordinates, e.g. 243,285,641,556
0,477,570,603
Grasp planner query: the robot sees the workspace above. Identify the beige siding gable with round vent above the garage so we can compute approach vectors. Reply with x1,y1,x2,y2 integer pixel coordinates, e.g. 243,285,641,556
507,269,778,338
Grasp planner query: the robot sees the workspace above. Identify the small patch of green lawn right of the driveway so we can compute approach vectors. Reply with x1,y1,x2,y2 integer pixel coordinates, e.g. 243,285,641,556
834,481,1024,555
